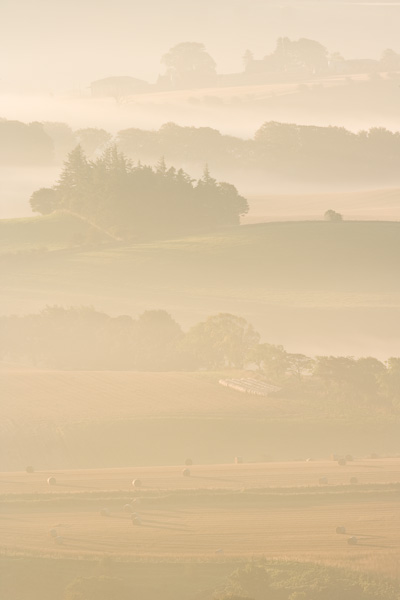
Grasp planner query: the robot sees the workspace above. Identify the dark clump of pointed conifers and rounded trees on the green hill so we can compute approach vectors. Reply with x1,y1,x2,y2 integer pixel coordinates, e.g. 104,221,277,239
30,146,248,239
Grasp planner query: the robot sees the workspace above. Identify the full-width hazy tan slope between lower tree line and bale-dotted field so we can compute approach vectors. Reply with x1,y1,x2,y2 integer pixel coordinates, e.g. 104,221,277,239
0,369,400,472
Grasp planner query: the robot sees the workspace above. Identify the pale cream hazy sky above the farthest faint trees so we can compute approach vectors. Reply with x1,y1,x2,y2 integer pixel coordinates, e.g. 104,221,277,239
0,0,400,91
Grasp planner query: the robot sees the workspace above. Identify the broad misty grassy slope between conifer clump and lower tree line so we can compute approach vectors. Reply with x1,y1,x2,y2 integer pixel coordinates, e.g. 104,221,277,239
1,217,400,358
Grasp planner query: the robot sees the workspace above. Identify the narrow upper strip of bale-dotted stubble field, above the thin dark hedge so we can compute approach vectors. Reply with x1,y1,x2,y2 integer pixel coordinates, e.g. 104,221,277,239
0,457,400,494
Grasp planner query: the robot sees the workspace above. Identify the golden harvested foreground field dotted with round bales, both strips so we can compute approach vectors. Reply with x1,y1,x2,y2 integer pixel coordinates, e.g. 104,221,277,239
0,459,400,575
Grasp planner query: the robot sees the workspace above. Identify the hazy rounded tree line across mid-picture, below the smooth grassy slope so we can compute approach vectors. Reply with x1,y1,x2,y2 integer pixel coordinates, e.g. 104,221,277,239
0,306,400,411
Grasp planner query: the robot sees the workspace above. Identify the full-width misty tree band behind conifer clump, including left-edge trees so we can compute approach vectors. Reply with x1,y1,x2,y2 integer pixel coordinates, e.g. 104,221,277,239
4,116,400,183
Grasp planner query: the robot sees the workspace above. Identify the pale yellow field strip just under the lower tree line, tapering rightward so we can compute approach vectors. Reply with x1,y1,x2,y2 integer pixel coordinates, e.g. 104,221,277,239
0,370,292,422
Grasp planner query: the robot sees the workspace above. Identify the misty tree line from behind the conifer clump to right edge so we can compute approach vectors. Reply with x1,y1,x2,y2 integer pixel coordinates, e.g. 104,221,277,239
116,121,400,182
